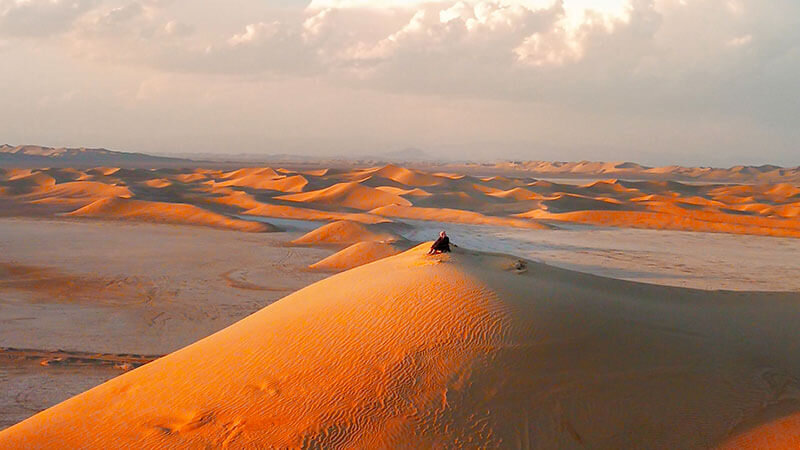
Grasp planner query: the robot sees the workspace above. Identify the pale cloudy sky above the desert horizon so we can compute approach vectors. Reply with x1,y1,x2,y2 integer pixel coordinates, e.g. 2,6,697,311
0,0,800,166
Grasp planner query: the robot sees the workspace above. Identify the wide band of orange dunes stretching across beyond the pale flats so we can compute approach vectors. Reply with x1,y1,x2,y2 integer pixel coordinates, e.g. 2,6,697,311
0,162,800,237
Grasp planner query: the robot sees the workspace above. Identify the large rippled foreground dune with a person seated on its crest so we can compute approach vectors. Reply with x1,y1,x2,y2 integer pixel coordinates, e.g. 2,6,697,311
0,244,800,449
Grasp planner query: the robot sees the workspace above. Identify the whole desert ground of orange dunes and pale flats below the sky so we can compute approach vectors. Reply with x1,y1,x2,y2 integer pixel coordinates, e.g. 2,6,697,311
0,149,800,448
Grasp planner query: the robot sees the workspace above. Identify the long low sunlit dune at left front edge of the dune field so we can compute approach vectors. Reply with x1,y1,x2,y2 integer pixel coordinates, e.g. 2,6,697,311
68,198,277,232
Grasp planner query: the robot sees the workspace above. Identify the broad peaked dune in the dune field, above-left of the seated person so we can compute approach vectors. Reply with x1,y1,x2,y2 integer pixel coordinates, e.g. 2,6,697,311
276,182,411,211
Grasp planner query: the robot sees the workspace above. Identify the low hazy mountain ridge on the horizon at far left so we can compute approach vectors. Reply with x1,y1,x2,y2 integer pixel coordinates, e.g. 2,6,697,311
0,144,196,168
